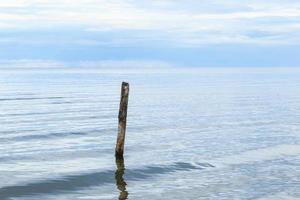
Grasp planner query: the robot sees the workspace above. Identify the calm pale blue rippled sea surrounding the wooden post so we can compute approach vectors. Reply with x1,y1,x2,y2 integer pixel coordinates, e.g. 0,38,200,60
0,68,300,200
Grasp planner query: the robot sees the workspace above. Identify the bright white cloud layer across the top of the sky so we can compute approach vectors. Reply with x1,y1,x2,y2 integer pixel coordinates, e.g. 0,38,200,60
0,0,300,45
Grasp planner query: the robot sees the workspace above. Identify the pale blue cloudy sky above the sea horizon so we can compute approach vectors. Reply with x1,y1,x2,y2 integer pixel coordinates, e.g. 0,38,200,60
0,0,300,67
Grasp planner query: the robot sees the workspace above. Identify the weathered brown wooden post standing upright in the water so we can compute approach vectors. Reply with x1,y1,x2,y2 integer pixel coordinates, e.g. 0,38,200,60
115,82,129,159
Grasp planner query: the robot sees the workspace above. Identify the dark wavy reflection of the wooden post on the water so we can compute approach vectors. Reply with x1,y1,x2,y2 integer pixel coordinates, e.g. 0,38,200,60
115,159,128,200
